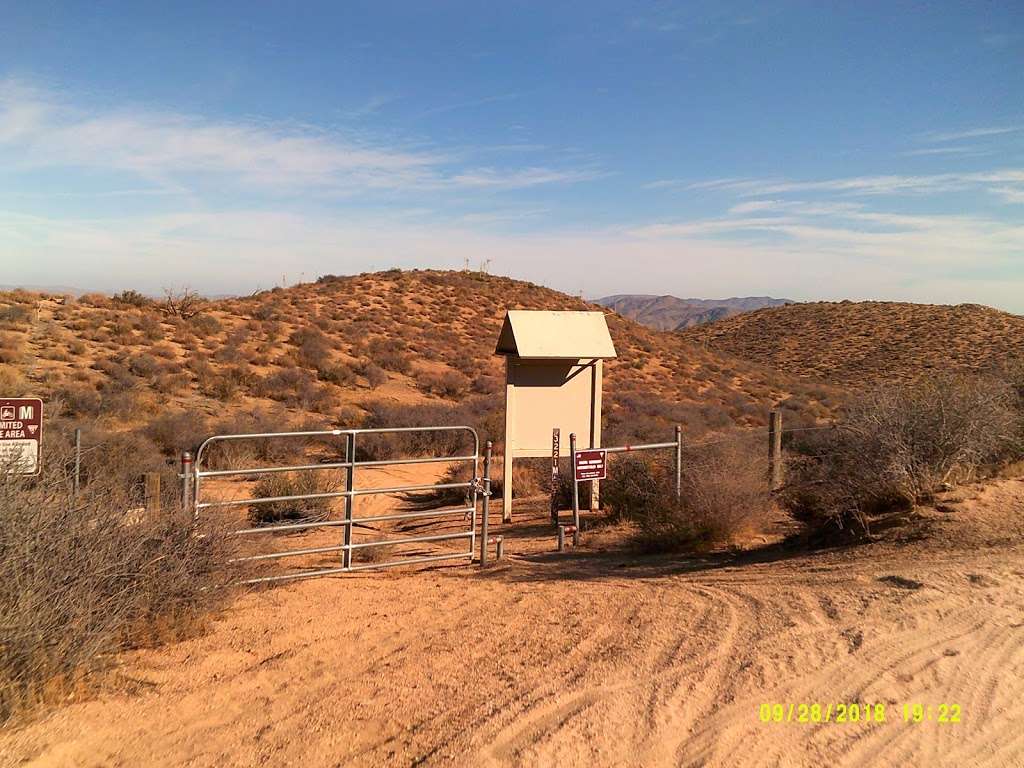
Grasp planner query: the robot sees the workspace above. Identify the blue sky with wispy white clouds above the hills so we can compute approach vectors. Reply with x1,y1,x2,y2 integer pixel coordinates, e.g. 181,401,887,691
0,0,1024,312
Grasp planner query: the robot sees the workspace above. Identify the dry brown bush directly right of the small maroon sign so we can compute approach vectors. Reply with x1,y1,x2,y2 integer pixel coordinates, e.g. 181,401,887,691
601,442,772,552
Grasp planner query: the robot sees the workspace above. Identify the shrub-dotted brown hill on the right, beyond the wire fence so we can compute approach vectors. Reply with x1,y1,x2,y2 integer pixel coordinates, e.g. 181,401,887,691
681,301,1024,387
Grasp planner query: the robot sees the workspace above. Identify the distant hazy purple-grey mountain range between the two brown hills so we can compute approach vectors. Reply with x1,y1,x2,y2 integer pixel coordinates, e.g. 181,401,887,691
596,294,794,331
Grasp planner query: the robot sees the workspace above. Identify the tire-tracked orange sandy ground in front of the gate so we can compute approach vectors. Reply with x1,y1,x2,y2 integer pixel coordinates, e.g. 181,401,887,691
0,480,1024,766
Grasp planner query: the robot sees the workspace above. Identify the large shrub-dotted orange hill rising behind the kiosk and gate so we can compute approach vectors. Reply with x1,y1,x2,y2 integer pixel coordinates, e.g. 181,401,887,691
0,269,837,450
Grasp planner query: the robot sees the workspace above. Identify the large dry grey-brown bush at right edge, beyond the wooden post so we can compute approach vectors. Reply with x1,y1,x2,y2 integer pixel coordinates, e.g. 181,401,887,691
783,376,1024,539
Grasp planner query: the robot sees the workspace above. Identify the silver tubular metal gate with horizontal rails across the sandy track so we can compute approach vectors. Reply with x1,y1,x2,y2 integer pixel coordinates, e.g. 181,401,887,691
191,425,487,584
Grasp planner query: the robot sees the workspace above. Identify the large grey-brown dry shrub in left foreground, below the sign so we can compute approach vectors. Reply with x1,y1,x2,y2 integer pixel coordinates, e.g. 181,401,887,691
0,440,230,720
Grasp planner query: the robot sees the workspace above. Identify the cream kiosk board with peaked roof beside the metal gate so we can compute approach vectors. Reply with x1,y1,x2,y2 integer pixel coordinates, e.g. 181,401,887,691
495,309,616,521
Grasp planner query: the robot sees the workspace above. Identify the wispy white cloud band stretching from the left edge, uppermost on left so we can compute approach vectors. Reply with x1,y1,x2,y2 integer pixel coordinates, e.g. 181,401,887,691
0,81,596,195
